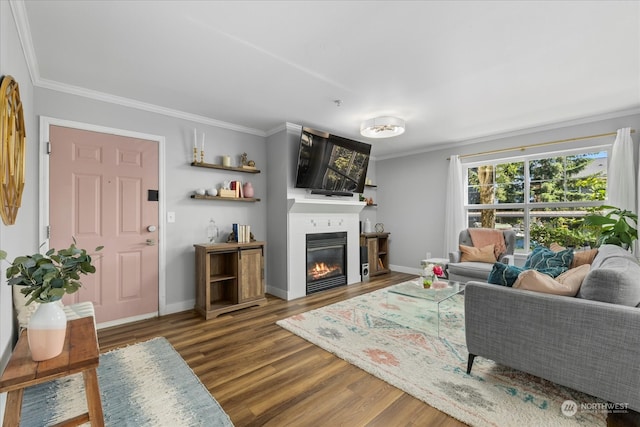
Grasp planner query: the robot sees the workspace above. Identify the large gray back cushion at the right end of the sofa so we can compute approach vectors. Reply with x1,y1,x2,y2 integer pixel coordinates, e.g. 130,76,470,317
578,245,640,307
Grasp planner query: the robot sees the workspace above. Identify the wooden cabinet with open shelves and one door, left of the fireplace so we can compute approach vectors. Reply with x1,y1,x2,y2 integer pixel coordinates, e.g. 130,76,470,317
194,242,267,320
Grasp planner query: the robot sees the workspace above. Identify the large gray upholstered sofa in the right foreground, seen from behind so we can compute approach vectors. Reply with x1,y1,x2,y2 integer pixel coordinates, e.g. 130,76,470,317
464,245,640,411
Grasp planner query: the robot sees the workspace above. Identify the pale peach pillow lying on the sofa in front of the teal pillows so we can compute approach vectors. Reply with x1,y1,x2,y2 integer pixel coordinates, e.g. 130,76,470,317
513,265,589,297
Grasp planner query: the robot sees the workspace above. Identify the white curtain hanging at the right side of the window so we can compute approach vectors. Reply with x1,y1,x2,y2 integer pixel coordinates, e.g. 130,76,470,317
607,128,638,212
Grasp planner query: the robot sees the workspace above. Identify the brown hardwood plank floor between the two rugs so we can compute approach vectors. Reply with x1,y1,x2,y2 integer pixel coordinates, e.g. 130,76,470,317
98,272,636,427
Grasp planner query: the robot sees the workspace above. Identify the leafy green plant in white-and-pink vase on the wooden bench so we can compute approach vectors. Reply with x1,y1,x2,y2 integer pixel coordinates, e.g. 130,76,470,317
0,239,102,361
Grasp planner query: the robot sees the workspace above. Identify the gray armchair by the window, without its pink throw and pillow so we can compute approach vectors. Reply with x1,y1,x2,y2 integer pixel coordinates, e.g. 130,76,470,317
447,228,516,283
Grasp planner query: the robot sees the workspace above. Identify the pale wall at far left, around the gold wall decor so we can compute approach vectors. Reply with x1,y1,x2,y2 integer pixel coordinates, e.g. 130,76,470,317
0,0,39,419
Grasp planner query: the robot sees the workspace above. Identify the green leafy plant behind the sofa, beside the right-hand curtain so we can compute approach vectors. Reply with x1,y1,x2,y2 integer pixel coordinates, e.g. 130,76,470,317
583,205,638,249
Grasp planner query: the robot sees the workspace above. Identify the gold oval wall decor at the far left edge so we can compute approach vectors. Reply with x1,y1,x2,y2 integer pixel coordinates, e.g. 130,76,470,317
0,76,27,225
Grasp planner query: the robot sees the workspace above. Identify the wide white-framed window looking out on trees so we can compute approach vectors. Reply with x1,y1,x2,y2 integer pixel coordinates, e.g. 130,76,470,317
464,147,609,252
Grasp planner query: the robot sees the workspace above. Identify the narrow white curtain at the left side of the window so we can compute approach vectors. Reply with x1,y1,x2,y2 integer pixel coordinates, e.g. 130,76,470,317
444,155,467,256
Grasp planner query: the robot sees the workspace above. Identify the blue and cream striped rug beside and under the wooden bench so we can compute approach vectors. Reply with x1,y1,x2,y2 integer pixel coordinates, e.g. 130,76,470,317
20,338,233,427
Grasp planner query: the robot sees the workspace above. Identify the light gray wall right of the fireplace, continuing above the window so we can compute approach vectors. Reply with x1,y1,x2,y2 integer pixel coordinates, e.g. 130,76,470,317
376,111,640,272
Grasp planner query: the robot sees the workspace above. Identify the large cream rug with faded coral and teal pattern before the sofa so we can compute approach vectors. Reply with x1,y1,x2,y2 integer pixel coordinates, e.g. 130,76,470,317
277,289,606,427
